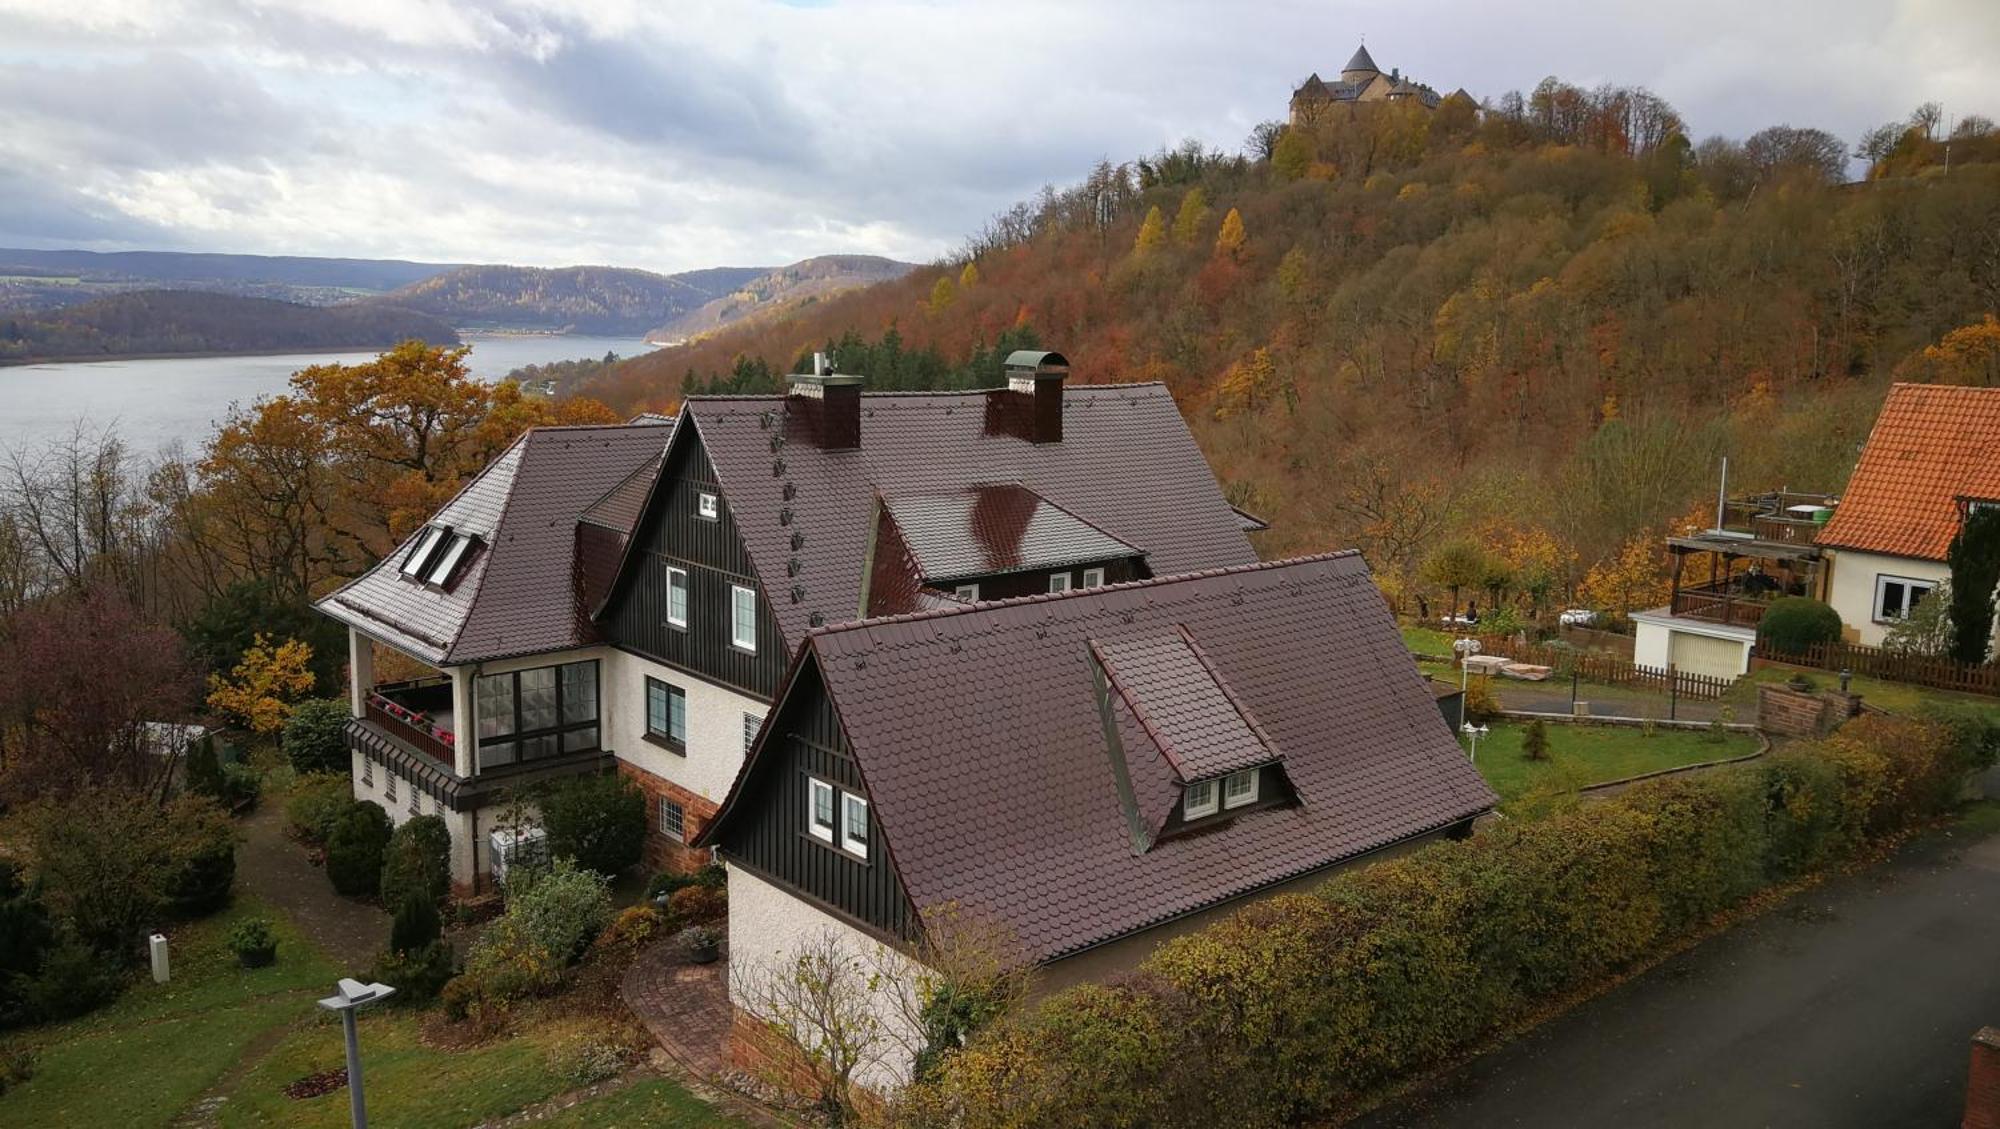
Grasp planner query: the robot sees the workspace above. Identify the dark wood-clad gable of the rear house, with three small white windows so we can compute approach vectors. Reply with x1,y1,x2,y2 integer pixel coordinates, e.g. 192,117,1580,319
604,430,786,699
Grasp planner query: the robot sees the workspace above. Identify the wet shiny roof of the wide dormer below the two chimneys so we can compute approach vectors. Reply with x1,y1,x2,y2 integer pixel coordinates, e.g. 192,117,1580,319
884,482,1144,585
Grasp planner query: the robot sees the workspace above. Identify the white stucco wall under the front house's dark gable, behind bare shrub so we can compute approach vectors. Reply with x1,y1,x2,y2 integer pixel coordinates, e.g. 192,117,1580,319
728,867,922,1095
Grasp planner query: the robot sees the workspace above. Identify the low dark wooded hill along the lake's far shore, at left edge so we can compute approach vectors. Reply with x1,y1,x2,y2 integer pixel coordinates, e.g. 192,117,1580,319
0,290,458,362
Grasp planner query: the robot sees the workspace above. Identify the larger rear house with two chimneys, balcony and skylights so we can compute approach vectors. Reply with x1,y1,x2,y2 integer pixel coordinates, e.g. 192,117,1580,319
318,352,1258,887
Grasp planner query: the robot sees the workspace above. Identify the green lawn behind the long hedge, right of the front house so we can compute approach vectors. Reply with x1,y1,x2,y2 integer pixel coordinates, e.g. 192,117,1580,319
1460,723,1758,807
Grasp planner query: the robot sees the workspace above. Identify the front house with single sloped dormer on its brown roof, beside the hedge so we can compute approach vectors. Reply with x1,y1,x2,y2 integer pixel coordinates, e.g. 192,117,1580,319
702,552,1496,1089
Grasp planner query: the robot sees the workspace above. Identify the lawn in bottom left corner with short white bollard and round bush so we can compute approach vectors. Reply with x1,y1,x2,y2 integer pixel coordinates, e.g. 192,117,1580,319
0,897,338,1127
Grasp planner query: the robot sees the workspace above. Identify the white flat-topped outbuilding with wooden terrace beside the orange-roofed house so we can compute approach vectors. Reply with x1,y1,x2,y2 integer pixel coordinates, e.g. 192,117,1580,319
1632,490,1840,679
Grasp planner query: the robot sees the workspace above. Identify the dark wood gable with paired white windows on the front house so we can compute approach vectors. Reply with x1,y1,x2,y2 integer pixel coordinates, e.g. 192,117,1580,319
720,663,916,937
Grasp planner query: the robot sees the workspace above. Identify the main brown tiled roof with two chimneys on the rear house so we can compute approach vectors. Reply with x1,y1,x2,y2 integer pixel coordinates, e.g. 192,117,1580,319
682,384,1256,649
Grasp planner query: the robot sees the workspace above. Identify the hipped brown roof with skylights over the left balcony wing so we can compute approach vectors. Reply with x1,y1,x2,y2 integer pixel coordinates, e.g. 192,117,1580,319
318,422,668,667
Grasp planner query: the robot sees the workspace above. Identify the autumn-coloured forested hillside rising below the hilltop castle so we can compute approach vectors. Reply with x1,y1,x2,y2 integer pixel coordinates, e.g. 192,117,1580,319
588,88,2000,604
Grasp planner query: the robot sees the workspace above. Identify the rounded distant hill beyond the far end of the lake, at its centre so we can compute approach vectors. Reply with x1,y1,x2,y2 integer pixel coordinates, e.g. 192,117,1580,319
372,266,770,336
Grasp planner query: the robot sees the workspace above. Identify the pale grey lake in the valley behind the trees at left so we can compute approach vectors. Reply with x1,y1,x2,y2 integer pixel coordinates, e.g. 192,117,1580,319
0,332,652,456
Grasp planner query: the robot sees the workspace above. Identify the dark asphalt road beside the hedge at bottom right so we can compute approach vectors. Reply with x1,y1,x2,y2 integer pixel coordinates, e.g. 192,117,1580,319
1362,816,2000,1129
